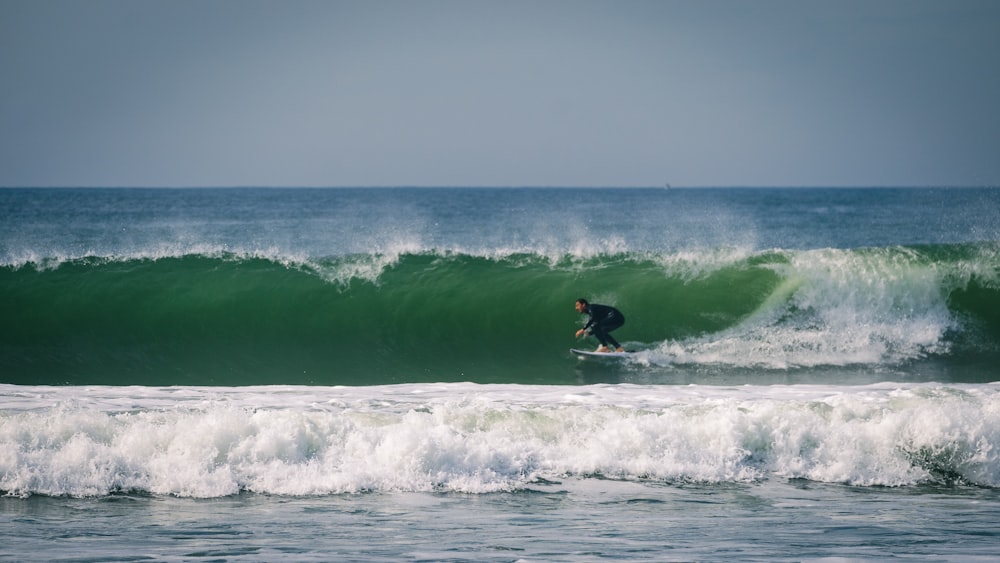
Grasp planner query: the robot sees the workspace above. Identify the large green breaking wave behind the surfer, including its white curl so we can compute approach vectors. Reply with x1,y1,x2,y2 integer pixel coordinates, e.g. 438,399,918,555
0,244,1000,385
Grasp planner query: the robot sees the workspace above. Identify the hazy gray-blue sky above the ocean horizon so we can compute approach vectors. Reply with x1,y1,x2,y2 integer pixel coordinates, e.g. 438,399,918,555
0,0,1000,186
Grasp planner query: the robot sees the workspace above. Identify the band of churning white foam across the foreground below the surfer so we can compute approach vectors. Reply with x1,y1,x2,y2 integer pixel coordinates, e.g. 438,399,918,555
0,383,1000,497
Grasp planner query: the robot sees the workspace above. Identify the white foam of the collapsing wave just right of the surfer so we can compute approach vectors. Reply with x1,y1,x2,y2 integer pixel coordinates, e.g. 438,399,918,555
648,248,960,369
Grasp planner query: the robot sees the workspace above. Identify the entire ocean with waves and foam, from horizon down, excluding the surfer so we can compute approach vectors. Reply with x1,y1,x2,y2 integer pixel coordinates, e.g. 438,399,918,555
0,188,1000,561
